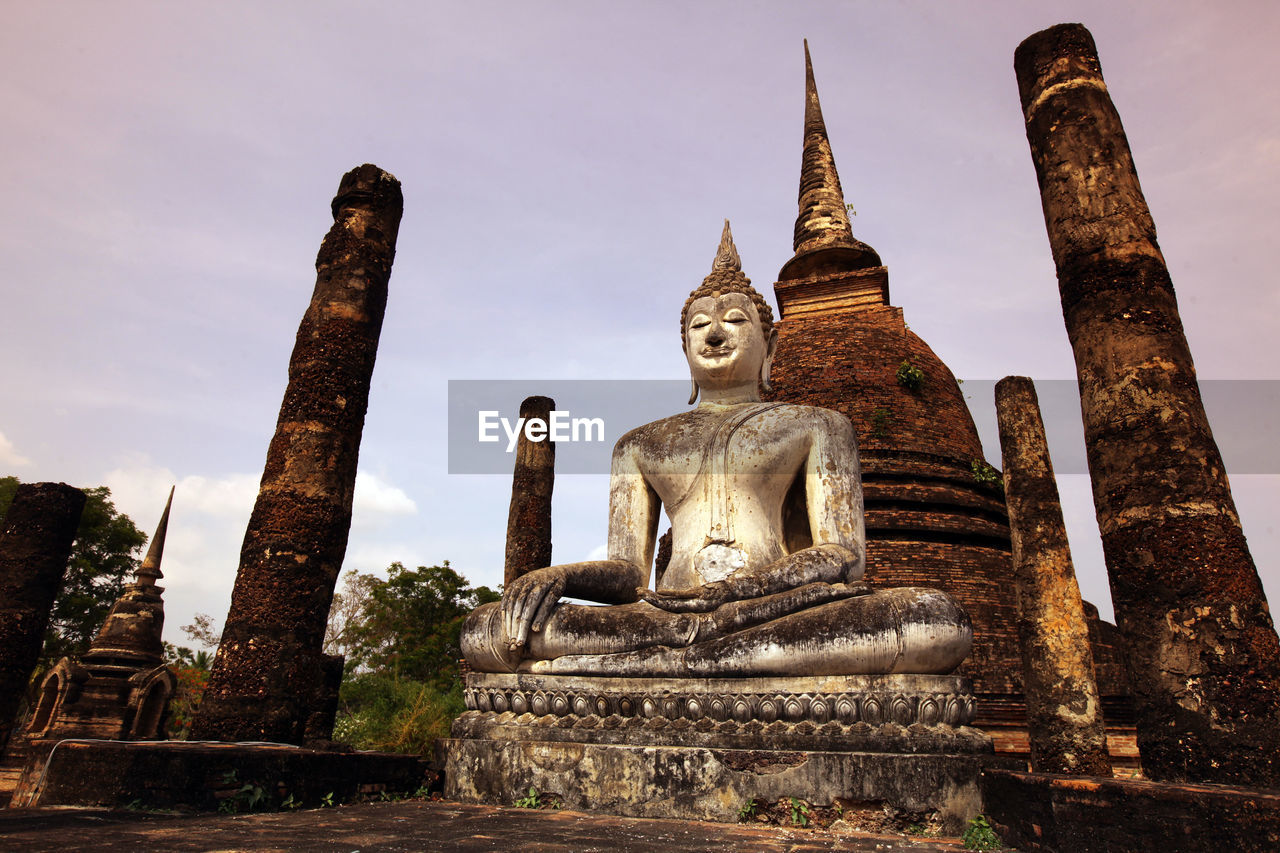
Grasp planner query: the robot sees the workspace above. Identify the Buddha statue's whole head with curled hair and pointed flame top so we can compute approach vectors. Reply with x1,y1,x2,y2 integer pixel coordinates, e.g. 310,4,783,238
680,219,777,405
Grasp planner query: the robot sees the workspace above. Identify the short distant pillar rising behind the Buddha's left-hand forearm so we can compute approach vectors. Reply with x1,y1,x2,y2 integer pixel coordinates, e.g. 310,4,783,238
502,396,556,585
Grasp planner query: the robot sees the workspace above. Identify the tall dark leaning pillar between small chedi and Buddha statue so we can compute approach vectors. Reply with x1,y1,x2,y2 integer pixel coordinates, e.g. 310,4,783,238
191,164,403,743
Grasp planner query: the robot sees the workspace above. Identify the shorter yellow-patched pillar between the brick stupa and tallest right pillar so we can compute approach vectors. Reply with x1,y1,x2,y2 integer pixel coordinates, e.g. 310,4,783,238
996,377,1111,776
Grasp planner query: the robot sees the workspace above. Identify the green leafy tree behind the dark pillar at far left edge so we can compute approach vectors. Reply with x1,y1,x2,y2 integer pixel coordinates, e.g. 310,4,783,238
0,476,147,669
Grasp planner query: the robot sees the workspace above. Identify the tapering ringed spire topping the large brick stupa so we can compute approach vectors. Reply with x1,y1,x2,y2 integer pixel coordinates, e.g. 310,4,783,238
780,40,881,280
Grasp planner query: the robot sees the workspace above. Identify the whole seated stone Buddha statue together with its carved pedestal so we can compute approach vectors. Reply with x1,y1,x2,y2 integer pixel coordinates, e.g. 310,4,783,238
445,223,1008,820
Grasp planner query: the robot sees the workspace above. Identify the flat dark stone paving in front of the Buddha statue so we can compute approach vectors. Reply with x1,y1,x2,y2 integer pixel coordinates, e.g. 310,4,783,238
0,800,964,853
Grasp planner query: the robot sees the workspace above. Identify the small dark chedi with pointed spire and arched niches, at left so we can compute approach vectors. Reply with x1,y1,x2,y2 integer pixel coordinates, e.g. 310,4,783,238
23,489,178,745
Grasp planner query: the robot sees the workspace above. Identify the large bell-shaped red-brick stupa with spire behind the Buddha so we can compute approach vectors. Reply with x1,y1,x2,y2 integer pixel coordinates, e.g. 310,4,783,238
757,45,1128,753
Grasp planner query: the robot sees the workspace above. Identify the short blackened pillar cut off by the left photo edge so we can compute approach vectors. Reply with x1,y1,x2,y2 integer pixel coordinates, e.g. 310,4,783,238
0,483,84,753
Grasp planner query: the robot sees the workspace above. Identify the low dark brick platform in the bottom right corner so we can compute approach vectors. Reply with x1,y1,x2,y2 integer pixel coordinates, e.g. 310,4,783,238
980,768,1280,853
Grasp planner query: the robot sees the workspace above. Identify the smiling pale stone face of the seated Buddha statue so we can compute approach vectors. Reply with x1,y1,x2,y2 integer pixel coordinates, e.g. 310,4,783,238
685,293,771,389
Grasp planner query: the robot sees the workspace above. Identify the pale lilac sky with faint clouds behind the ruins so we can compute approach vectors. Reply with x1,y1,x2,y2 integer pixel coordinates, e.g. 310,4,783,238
0,0,1280,642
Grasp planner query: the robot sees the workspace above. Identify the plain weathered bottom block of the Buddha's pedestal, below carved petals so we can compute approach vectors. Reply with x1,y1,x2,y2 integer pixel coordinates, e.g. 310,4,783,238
444,740,1016,826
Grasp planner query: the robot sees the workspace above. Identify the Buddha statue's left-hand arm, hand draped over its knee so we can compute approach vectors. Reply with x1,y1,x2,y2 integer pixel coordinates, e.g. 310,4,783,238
502,438,662,647
